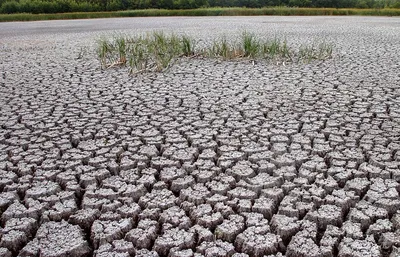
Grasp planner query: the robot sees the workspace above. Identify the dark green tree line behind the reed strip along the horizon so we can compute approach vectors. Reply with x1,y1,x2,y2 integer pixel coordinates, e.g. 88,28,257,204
0,0,400,13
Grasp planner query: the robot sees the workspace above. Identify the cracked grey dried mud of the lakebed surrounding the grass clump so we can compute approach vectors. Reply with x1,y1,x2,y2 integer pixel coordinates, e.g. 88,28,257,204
0,17,400,257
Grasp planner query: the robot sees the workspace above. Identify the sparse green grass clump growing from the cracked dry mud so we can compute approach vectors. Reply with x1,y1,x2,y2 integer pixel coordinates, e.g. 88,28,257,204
97,32,333,74
